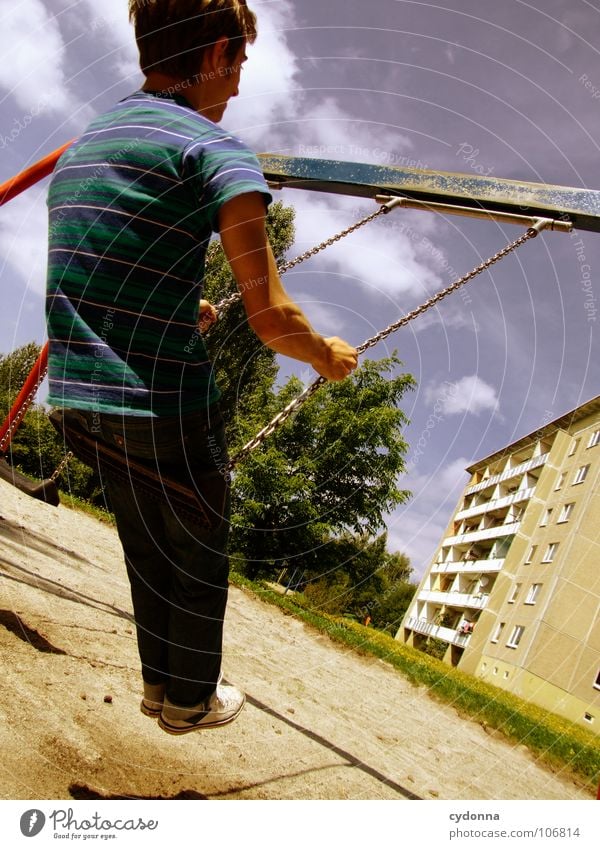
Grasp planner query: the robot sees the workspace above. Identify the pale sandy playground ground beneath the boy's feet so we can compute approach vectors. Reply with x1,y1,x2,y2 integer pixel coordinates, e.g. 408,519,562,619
0,481,592,799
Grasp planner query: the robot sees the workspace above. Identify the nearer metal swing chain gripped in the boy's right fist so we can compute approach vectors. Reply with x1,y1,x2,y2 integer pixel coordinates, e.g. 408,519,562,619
223,224,538,474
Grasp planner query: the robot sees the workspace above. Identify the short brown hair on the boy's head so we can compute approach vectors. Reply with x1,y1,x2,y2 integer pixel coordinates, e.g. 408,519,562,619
129,0,256,79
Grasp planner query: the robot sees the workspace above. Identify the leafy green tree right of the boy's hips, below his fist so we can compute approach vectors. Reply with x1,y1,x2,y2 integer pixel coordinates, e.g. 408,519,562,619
232,355,414,584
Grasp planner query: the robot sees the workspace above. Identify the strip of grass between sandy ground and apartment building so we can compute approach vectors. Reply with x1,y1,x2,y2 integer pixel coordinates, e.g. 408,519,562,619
231,573,600,793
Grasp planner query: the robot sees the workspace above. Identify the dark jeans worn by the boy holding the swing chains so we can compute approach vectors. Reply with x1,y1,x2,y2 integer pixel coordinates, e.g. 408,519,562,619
71,408,230,707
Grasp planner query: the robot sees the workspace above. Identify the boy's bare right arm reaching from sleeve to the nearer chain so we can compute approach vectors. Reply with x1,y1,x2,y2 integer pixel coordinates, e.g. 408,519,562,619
219,192,357,380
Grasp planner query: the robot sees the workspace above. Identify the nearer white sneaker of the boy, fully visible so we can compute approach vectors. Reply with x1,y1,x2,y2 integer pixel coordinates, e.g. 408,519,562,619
158,682,246,734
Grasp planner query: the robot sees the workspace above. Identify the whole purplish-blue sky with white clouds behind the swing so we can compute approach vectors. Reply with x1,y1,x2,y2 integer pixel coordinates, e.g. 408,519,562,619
0,0,600,578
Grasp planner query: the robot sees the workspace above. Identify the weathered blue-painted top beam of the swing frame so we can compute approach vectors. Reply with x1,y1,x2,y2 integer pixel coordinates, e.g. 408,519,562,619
259,153,600,233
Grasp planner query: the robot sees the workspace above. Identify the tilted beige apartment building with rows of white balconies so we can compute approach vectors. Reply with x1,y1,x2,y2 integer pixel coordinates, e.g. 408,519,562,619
396,396,600,733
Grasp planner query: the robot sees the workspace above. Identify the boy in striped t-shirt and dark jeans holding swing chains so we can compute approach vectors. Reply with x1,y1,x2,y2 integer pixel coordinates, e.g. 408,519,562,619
47,0,357,734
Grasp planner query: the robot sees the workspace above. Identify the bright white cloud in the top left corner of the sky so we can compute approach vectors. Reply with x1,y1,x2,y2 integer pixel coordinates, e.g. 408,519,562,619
0,0,73,114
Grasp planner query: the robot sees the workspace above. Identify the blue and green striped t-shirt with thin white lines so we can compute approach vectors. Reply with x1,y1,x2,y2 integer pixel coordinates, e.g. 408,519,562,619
47,91,270,416
